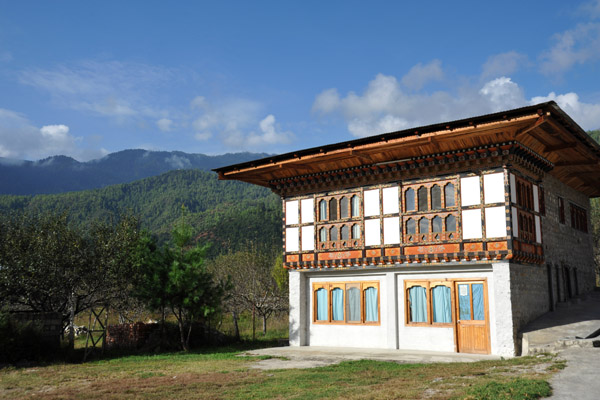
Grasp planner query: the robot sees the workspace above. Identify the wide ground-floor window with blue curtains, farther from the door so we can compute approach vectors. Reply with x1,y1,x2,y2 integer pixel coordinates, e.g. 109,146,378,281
313,282,379,324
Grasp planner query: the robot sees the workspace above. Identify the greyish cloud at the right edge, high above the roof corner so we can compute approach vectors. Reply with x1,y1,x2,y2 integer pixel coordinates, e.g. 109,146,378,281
540,23,600,76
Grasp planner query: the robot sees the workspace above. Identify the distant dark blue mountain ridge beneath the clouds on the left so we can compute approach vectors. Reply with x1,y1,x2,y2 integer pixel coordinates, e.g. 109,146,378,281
0,150,268,195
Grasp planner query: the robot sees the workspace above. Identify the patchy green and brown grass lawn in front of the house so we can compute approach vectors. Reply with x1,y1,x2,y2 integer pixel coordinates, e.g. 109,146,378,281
0,346,564,399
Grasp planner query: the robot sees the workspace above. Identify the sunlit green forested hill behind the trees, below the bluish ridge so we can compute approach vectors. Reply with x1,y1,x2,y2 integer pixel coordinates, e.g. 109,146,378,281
0,170,282,255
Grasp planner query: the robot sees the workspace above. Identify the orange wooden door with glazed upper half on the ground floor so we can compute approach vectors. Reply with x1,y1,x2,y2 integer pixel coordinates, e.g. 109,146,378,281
455,281,490,354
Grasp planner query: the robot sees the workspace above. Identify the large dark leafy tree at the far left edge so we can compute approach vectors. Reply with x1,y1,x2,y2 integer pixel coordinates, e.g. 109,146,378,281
0,213,139,346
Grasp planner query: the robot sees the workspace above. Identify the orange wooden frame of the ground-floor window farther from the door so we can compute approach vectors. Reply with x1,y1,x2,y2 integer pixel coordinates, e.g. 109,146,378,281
312,281,381,326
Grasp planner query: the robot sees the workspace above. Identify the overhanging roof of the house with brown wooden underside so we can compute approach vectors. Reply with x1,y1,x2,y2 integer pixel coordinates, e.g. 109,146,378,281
214,101,600,197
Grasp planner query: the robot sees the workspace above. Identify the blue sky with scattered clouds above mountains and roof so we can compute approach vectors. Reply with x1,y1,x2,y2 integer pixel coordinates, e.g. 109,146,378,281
0,0,600,161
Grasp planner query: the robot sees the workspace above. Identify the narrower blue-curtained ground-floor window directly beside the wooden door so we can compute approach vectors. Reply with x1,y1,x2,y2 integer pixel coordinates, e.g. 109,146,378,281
404,280,453,326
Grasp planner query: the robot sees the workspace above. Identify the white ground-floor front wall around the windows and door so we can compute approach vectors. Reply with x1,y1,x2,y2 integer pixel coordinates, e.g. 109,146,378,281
290,262,515,356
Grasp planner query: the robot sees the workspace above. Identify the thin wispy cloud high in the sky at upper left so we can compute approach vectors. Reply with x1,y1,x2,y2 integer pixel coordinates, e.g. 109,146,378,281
19,60,172,120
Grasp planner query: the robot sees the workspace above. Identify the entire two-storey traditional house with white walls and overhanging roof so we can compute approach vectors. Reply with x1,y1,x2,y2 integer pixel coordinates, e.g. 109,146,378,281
215,102,600,356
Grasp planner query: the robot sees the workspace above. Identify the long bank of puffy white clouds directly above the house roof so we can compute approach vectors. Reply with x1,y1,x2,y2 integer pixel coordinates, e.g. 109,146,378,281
313,74,600,137
